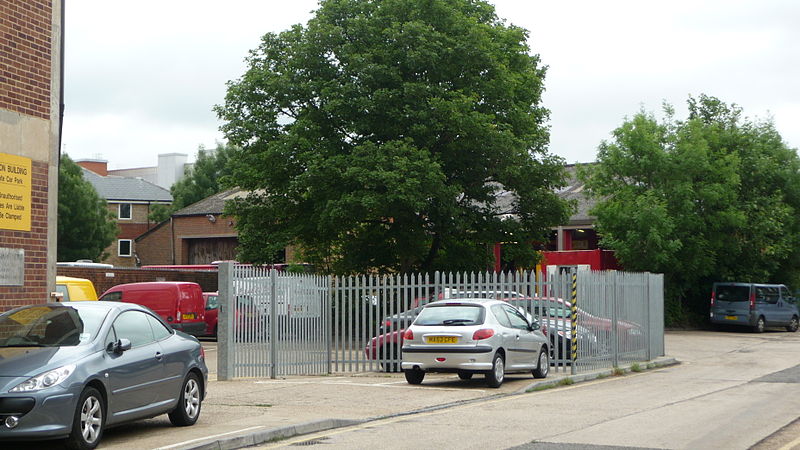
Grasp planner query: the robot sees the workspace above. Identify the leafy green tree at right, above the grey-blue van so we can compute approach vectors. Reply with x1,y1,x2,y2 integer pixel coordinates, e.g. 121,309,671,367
583,95,800,322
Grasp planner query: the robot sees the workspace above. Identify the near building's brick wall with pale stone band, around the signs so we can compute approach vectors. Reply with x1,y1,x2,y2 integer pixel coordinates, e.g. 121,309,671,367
0,0,58,311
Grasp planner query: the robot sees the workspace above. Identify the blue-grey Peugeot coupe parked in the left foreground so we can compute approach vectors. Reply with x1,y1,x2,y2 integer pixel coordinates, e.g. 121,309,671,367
0,302,208,449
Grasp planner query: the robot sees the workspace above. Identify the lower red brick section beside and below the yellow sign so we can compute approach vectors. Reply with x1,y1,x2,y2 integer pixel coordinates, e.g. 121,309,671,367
0,161,49,312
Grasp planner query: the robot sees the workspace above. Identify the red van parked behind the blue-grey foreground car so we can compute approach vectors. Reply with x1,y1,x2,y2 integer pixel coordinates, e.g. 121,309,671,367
99,281,206,336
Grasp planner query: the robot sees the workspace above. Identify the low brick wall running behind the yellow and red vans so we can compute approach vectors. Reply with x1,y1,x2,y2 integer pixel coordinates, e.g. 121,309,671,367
57,267,219,296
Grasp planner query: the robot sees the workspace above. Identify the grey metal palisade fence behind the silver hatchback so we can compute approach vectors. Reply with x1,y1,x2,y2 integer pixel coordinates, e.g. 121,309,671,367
218,263,664,380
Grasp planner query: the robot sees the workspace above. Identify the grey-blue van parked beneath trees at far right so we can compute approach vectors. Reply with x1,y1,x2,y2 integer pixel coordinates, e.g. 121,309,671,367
711,283,800,333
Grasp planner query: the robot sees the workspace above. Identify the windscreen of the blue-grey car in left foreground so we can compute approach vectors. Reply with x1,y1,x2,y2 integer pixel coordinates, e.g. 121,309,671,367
0,305,108,347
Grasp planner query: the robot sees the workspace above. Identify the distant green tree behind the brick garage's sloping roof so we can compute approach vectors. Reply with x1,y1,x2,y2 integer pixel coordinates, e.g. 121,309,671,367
150,143,231,222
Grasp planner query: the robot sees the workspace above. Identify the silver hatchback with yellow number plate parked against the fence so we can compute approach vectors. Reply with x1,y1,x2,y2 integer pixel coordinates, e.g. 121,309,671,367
402,298,550,387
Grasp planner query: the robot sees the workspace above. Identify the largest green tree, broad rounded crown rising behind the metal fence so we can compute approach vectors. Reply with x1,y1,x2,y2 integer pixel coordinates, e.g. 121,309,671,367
217,0,568,273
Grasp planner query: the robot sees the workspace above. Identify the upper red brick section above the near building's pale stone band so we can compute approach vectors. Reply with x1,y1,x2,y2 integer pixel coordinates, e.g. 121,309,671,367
0,0,52,120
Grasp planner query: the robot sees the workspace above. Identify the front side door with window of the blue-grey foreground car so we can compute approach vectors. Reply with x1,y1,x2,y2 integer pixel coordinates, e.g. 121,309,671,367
105,311,164,422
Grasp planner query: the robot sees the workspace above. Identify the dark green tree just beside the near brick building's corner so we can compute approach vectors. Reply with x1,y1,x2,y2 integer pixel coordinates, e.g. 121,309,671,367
57,155,118,261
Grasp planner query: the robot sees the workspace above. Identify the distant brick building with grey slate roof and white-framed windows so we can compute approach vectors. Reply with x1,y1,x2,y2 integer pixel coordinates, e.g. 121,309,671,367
76,160,172,267
